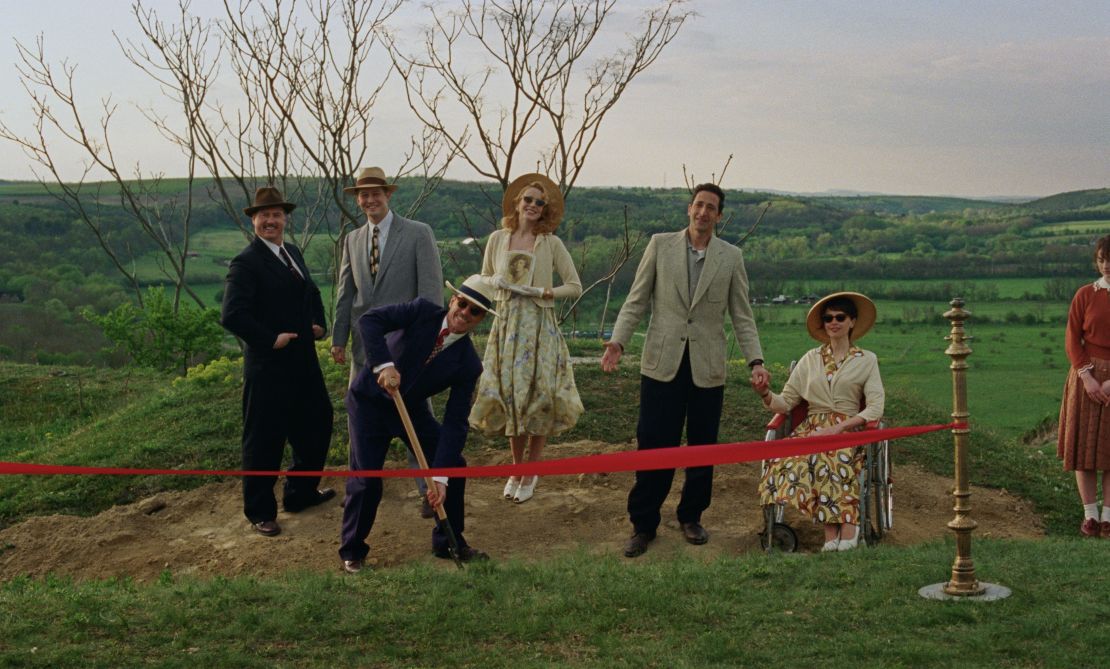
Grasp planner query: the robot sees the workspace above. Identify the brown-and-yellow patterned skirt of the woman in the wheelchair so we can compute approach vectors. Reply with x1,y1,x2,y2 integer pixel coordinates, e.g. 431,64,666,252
759,412,864,525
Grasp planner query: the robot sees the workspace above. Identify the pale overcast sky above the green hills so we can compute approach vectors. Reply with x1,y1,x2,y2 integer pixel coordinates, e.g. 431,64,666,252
0,0,1110,196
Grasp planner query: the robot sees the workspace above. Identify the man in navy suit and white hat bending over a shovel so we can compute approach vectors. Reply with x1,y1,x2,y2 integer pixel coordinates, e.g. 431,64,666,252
340,274,496,574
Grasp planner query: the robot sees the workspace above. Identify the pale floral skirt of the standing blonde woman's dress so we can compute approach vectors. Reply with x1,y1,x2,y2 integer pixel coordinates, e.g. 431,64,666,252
471,295,583,437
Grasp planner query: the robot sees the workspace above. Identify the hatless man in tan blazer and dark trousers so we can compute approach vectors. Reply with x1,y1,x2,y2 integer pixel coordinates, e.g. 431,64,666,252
602,183,770,557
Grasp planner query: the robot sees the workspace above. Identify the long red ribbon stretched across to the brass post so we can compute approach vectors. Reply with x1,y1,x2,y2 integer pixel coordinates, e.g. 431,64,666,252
0,423,967,478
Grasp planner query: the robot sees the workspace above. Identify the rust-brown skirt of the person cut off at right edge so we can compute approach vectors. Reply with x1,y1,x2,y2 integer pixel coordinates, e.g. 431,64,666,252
1056,358,1110,472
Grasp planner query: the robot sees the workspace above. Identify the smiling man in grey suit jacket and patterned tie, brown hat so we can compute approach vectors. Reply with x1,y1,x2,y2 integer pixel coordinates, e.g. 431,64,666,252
332,168,443,517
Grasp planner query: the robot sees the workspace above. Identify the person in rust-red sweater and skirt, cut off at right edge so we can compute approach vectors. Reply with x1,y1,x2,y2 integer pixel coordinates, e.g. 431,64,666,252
1057,235,1110,538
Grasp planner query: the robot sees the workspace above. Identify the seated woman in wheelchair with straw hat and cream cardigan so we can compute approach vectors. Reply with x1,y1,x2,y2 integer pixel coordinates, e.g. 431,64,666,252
753,293,884,551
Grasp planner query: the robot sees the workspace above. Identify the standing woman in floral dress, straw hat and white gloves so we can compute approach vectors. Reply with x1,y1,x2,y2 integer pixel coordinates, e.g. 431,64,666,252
471,174,583,503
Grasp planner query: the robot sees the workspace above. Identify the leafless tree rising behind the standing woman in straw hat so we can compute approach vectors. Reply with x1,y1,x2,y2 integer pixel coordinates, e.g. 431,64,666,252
386,0,693,322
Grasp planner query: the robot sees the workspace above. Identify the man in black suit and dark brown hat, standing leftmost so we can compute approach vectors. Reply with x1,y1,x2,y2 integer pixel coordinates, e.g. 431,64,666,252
221,187,335,537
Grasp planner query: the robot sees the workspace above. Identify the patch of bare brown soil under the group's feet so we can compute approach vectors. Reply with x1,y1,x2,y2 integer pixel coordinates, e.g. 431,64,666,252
0,442,1043,580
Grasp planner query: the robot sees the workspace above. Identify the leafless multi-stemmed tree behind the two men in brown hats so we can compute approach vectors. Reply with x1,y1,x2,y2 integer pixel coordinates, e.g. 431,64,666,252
0,0,451,315
